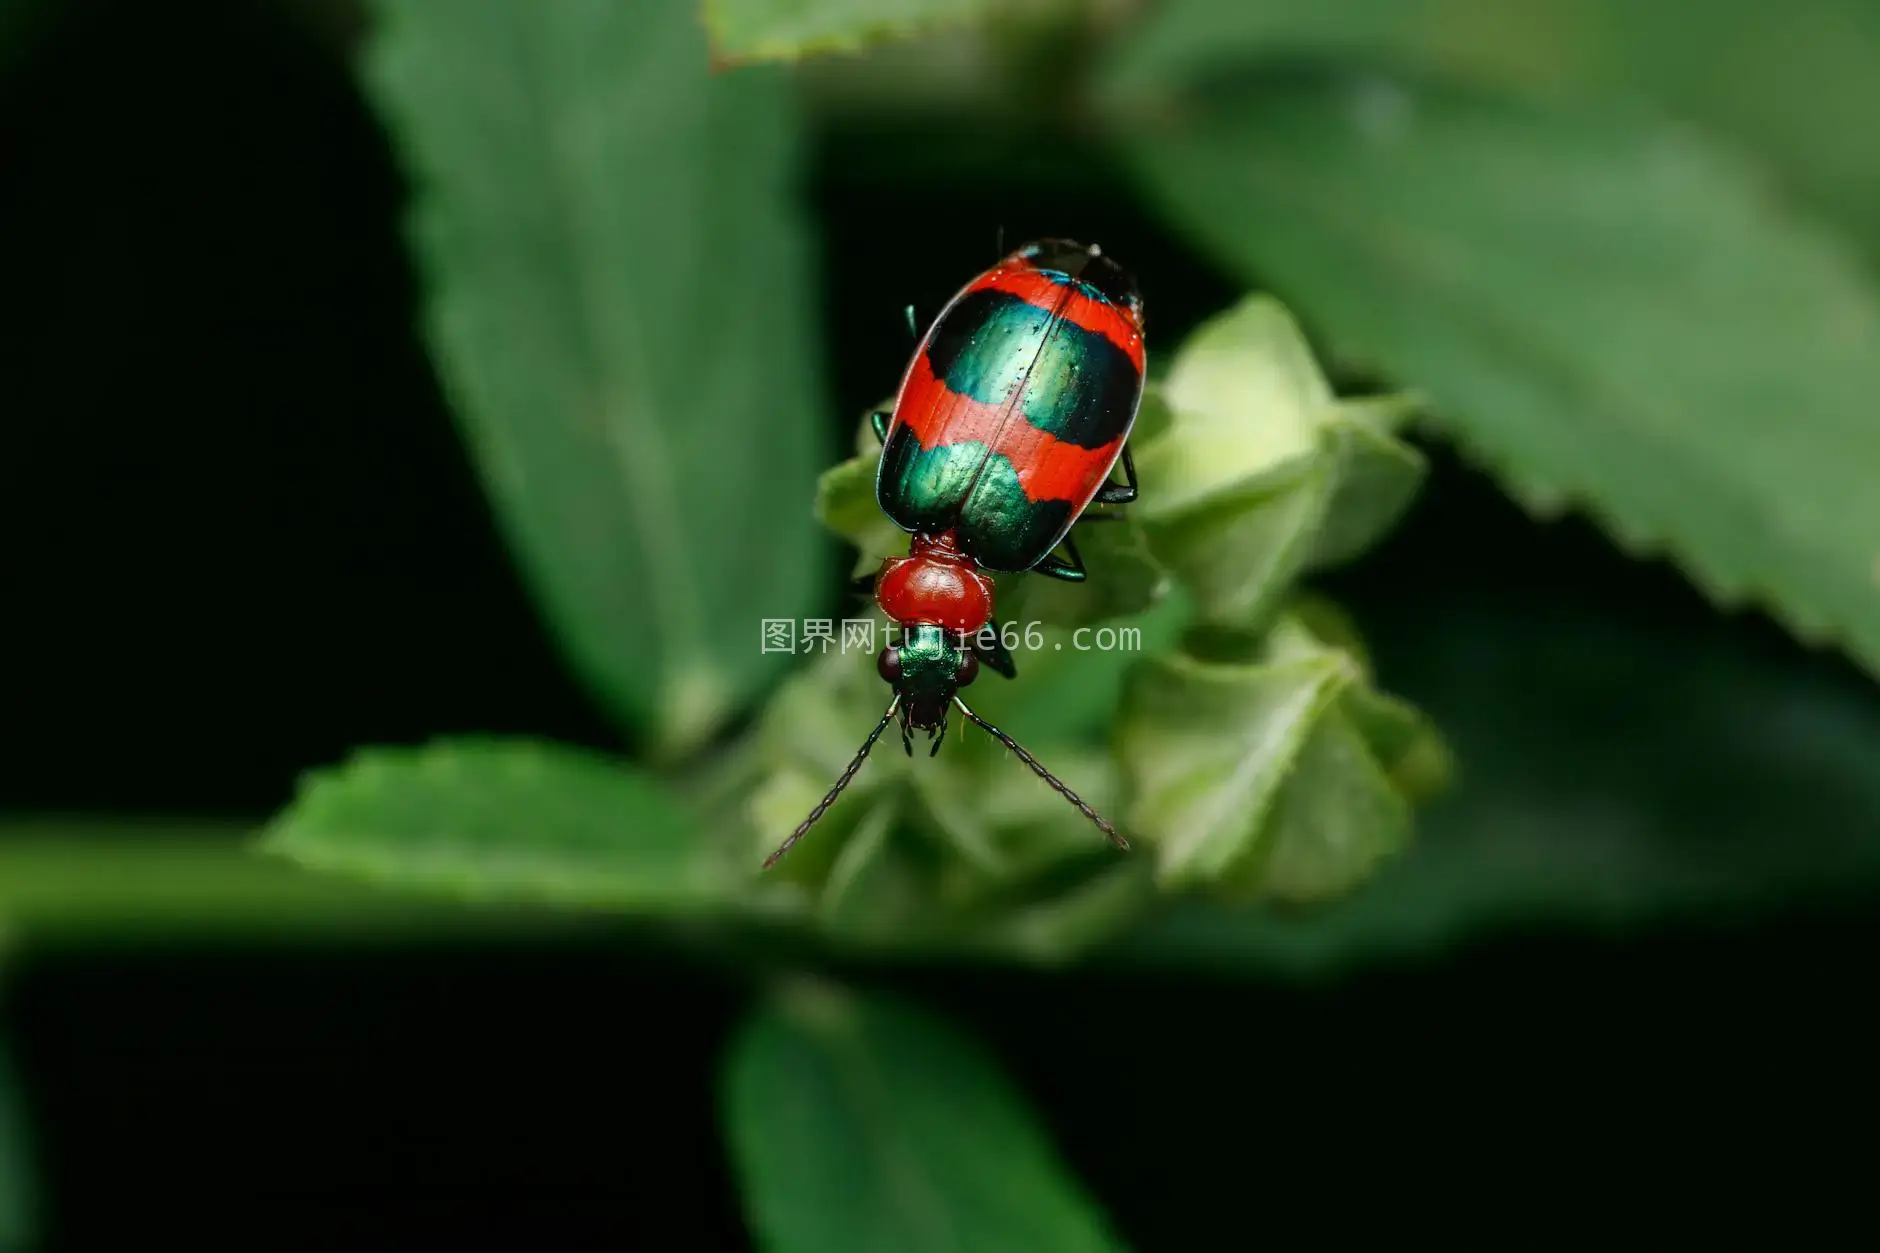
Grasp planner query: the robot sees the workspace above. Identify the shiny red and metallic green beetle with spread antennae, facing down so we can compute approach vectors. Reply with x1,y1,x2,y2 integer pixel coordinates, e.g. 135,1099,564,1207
765,239,1143,867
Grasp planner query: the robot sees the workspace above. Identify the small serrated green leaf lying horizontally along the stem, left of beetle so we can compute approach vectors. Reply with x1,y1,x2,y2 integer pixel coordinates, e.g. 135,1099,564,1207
261,739,739,912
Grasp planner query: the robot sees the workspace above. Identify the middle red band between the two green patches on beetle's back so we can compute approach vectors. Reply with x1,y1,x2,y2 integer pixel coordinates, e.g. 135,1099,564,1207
889,352,1120,508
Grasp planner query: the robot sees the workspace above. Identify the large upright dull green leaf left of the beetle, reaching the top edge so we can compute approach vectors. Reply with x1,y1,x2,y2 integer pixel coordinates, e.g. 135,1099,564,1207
365,0,823,754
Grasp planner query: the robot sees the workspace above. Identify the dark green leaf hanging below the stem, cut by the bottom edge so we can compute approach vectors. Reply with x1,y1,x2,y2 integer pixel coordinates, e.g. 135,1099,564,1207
724,986,1122,1253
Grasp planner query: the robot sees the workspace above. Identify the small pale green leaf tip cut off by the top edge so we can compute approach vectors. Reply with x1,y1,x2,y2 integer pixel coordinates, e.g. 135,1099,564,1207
703,0,995,64
